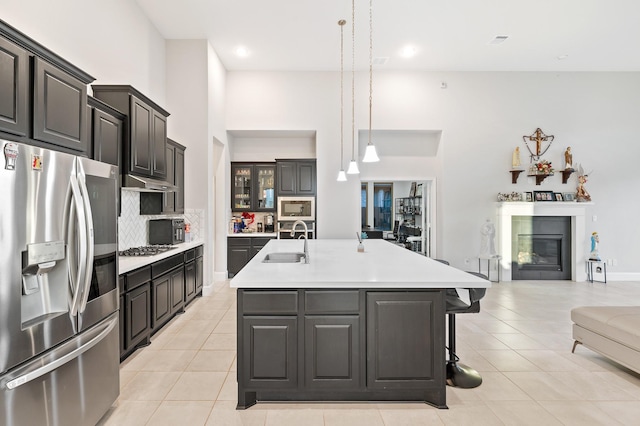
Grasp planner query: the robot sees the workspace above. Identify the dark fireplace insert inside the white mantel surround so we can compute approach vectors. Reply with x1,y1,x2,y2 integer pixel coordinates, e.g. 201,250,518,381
511,216,571,280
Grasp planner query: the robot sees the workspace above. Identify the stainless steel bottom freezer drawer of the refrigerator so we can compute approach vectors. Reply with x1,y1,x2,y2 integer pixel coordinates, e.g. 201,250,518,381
0,312,120,426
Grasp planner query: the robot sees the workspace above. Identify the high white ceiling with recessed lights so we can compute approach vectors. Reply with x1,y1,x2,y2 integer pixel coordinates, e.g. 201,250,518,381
136,0,640,71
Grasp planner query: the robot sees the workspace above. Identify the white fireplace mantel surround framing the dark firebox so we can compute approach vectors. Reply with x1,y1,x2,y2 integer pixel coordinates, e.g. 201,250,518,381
496,201,593,281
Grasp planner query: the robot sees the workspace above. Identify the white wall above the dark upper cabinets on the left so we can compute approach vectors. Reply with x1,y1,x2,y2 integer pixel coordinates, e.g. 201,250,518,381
0,0,166,103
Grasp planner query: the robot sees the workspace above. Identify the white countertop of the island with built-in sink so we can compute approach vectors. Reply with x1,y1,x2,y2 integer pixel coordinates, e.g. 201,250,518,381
231,239,491,288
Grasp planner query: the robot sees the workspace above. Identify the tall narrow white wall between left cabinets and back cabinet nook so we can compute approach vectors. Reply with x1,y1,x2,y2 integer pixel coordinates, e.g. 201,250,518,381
166,40,228,291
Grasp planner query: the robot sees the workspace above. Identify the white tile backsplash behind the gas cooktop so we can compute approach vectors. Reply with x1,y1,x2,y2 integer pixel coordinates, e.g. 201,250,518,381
118,189,204,250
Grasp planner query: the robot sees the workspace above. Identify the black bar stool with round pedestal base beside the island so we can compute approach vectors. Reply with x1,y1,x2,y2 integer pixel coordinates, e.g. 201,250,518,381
445,271,488,389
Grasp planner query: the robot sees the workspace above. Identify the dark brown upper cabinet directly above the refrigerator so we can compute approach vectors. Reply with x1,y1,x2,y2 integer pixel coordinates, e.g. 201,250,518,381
0,20,94,155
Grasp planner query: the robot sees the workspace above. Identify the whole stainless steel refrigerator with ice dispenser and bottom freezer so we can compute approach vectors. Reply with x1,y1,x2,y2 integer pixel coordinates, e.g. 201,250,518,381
0,139,120,425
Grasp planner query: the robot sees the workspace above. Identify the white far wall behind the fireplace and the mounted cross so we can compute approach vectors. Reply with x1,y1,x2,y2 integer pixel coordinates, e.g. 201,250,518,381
227,72,640,274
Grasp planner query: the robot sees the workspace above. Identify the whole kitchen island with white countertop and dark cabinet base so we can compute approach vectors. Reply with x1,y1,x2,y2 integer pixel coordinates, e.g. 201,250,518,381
231,240,491,409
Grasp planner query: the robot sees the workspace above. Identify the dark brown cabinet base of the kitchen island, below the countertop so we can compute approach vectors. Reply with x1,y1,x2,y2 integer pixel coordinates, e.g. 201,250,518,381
237,289,446,408
